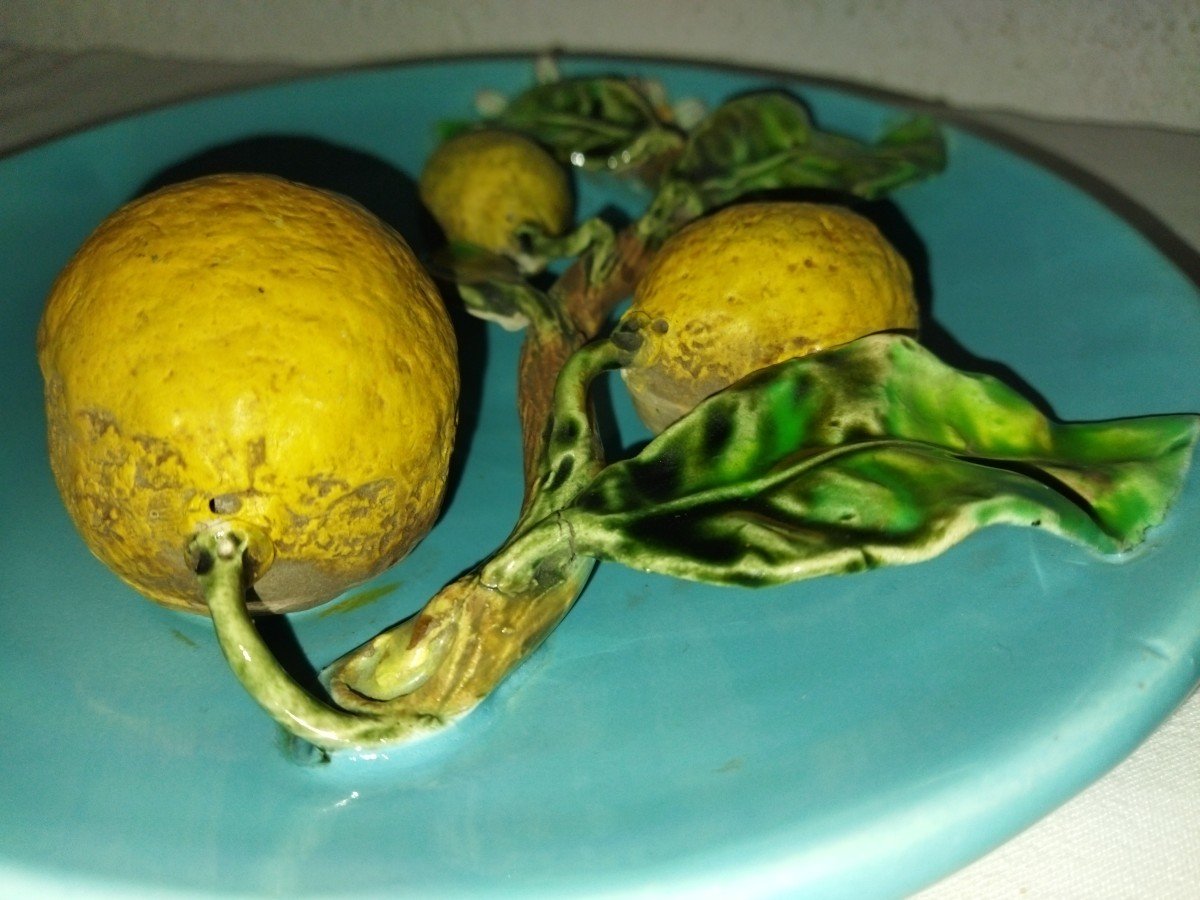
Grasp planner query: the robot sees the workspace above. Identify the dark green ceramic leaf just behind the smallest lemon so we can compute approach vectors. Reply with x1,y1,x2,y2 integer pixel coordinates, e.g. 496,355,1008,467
494,77,679,170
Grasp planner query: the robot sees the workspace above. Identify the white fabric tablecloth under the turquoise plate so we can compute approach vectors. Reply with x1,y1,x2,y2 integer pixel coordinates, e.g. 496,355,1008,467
0,46,1200,900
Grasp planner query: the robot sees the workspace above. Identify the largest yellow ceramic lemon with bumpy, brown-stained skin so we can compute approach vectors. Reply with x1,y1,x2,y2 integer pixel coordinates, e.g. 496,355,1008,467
37,175,458,612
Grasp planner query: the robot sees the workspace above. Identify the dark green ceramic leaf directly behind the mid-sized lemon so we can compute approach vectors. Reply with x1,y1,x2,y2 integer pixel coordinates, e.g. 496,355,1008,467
672,91,946,206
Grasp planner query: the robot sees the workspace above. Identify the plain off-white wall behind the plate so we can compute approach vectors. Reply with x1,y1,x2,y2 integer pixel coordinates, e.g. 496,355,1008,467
7,0,1200,130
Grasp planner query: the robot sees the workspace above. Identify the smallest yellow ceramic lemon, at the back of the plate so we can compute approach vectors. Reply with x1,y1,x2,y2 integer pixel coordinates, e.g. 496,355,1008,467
420,128,572,254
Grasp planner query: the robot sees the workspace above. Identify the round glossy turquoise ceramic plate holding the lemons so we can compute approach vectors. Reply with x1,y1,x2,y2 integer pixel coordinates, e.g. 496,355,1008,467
0,60,1200,898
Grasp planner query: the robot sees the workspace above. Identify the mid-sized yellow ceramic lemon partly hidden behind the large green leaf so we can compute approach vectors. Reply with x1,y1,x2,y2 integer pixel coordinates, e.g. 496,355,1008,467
624,202,918,431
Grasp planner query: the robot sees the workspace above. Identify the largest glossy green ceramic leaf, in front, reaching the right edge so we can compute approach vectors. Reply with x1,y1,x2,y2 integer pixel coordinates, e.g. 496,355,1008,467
554,335,1200,584
